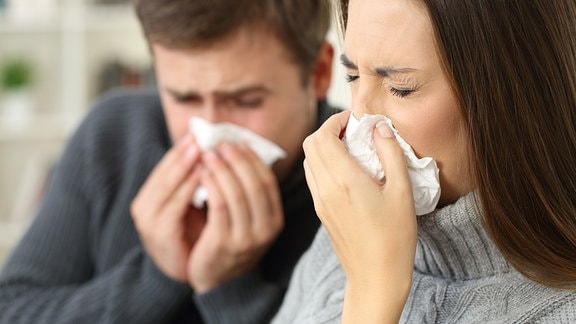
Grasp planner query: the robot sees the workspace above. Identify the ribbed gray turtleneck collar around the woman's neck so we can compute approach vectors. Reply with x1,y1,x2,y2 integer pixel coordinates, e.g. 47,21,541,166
415,193,510,280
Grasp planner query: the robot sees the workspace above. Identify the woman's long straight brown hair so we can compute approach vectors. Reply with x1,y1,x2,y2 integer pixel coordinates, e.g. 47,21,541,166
340,0,576,289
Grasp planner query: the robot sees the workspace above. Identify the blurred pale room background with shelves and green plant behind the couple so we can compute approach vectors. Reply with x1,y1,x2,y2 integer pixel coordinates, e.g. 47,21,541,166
0,0,350,267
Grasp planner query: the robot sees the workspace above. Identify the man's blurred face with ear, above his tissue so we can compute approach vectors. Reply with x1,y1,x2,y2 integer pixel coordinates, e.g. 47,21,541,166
152,31,324,175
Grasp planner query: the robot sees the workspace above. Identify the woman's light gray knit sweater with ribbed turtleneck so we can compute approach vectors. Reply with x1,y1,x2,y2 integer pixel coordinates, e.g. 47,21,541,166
273,194,576,324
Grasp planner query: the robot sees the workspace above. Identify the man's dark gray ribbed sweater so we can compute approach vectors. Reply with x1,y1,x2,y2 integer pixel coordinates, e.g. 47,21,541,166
0,91,337,324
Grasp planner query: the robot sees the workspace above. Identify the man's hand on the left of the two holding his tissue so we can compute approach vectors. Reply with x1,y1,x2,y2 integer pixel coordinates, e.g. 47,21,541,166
131,136,205,281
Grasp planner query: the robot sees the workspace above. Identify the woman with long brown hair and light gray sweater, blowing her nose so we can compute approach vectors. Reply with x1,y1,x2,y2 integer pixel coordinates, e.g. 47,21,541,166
275,0,576,323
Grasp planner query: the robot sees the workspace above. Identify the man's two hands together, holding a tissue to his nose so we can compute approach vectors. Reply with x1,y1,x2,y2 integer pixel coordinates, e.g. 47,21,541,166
131,136,284,293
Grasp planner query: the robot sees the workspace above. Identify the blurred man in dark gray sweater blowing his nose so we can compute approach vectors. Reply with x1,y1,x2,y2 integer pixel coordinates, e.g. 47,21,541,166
0,0,336,323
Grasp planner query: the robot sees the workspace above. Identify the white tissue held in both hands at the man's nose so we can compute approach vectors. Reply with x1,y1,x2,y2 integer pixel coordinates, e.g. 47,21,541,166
188,117,286,208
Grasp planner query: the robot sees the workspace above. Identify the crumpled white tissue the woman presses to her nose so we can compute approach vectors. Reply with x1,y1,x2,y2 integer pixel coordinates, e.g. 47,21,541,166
342,114,440,215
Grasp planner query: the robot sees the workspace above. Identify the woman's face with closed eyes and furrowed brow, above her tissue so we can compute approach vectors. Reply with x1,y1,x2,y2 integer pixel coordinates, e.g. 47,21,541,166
342,0,472,205
